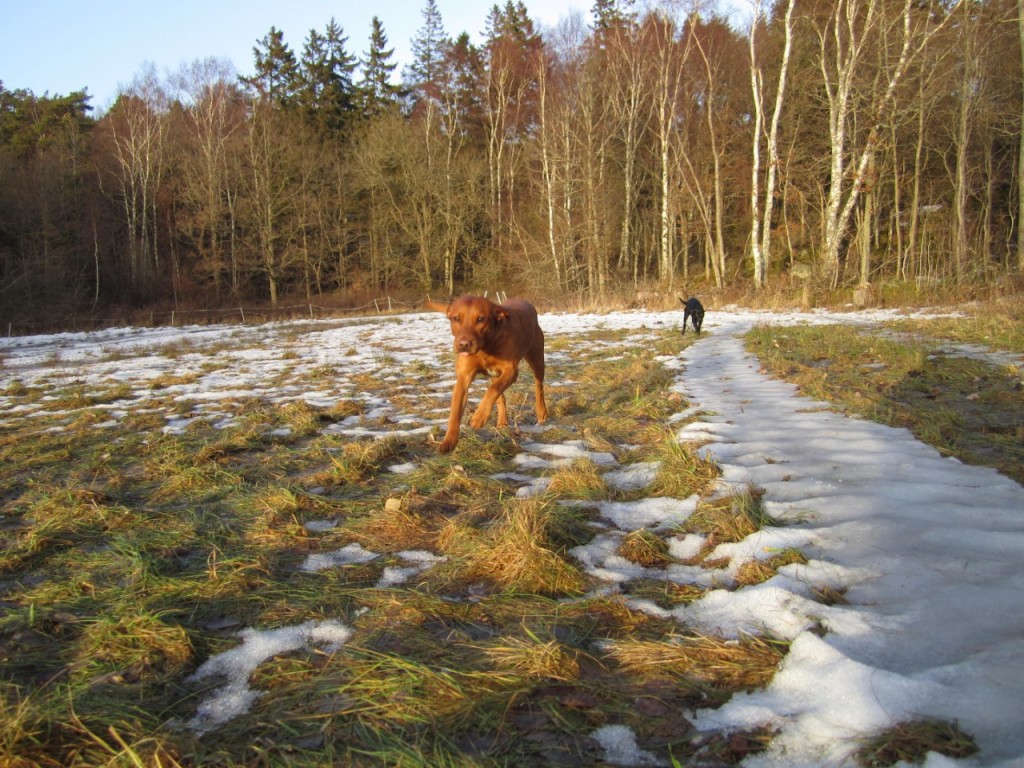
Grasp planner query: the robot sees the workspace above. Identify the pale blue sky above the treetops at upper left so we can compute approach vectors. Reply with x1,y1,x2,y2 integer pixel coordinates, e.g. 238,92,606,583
0,0,593,111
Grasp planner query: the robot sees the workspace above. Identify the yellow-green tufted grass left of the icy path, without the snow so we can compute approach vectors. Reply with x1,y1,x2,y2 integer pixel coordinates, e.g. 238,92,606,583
0,321,815,768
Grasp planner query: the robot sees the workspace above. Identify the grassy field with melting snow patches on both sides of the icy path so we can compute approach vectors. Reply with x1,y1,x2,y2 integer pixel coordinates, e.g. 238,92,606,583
0,312,1024,766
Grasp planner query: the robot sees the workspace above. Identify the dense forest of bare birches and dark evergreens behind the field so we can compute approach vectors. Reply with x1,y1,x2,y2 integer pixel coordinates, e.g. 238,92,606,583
0,0,1024,323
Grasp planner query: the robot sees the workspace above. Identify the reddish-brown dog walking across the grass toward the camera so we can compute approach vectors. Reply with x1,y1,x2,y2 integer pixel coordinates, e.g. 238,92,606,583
426,296,548,454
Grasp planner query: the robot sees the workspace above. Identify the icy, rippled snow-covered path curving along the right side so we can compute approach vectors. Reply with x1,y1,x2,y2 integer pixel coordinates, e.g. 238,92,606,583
678,314,1024,766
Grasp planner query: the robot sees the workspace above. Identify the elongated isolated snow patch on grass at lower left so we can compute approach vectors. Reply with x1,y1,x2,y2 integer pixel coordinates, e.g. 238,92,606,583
187,621,352,735
